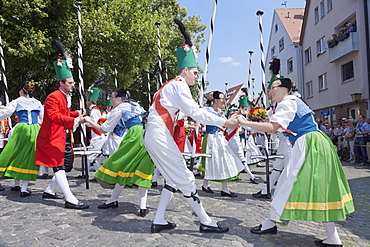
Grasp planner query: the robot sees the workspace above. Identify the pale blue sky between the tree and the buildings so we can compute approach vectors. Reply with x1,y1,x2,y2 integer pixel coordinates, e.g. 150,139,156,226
177,0,306,94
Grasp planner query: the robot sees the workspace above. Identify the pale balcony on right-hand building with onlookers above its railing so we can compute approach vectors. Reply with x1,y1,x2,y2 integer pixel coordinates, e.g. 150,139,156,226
329,32,359,63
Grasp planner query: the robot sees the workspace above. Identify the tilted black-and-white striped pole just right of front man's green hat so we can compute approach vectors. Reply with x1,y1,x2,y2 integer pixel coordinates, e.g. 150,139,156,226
190,0,217,171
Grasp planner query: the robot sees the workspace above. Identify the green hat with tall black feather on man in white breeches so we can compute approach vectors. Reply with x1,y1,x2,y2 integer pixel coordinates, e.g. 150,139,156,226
174,19,198,71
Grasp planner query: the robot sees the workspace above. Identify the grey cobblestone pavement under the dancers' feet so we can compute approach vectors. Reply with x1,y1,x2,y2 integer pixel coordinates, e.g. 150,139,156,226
0,158,370,247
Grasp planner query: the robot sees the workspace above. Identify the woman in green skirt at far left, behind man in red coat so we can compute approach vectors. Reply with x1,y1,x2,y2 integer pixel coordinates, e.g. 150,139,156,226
0,83,44,197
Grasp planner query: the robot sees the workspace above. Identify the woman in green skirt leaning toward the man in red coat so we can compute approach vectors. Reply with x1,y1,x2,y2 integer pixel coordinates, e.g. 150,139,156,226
85,89,154,217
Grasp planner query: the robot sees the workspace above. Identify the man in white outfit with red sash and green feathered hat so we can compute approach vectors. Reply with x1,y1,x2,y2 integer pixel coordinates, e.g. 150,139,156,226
144,20,237,233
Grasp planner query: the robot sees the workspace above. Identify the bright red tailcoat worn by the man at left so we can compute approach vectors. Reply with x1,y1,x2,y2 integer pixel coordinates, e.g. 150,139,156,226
36,90,79,167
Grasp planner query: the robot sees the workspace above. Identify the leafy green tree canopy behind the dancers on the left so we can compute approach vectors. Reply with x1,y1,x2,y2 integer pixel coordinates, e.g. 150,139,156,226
0,0,205,107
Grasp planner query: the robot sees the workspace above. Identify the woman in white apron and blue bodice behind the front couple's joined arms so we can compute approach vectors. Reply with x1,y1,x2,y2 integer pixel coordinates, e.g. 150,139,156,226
200,91,245,197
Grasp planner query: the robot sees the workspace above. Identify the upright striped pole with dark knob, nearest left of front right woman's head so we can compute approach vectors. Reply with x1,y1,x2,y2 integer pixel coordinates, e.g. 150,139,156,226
256,10,270,195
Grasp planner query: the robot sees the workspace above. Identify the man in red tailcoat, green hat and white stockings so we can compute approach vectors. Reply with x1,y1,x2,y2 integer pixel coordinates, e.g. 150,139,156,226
36,44,89,209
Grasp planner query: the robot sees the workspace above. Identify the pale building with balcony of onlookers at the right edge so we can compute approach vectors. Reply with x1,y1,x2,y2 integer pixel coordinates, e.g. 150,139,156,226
300,0,369,122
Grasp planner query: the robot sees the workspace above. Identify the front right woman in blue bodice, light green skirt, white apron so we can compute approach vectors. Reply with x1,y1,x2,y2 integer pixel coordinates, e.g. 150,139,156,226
238,78,354,246
